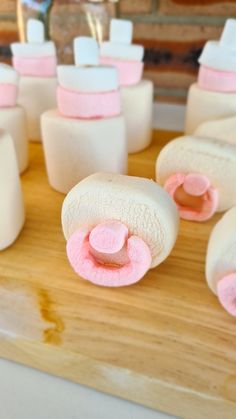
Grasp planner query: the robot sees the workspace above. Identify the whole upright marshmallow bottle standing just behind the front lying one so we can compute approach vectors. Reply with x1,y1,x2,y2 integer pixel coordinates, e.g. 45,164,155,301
42,37,128,193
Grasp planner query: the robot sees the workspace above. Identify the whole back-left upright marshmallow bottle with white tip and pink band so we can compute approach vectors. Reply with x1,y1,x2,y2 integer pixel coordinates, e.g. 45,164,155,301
11,19,57,141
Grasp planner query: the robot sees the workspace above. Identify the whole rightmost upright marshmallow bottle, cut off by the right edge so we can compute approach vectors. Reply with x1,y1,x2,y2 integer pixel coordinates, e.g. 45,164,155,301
185,19,236,135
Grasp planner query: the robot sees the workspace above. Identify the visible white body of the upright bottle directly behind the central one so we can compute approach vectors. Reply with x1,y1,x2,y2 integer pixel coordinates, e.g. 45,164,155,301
121,80,153,153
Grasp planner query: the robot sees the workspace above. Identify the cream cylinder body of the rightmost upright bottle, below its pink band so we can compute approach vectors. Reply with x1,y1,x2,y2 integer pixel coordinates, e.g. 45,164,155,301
185,83,236,134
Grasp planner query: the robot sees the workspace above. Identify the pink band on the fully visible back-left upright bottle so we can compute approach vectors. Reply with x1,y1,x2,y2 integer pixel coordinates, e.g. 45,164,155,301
12,56,57,77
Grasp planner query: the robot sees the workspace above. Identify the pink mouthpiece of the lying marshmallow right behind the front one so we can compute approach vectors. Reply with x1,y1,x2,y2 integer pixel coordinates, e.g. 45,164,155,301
164,173,218,221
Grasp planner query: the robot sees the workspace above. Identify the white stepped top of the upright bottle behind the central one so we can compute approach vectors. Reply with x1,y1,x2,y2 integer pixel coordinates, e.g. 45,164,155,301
100,19,144,61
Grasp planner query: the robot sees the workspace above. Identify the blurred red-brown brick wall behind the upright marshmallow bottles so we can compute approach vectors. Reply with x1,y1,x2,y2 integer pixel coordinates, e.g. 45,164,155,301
0,0,236,101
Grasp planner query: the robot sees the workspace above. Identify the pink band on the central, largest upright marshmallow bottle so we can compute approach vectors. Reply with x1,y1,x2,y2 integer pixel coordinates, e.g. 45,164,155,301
57,86,121,119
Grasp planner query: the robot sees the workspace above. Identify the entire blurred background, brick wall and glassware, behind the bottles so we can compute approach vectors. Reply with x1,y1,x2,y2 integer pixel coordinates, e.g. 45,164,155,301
0,0,232,103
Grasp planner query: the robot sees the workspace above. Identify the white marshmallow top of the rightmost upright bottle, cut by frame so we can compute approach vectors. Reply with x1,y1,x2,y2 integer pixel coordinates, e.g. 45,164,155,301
198,19,236,71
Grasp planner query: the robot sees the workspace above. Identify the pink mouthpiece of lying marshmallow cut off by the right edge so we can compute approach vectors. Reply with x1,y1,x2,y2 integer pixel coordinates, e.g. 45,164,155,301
217,273,236,316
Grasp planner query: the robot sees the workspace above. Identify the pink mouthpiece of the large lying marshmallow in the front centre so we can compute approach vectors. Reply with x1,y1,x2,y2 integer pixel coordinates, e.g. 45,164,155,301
67,221,152,287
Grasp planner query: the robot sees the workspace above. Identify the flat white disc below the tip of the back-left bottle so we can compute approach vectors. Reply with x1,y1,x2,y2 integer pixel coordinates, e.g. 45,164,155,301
11,41,56,58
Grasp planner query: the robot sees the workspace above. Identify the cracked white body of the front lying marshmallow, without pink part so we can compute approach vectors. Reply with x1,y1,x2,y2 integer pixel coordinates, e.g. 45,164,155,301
62,173,179,268
